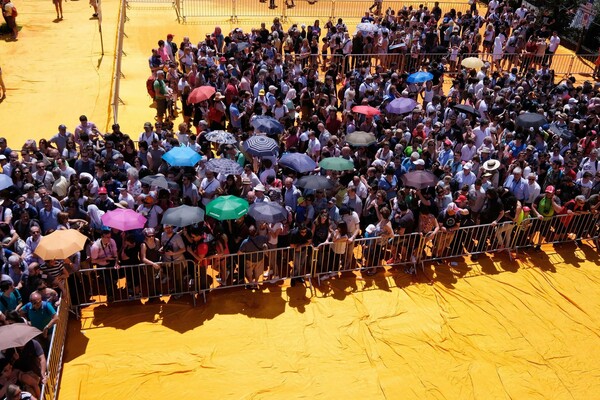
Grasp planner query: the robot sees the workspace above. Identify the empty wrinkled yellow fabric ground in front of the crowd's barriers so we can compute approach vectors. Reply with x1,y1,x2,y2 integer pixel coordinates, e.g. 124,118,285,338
61,245,600,400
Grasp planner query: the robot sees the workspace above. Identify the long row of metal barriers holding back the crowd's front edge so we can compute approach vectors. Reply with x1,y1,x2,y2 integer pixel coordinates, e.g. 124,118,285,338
67,212,600,316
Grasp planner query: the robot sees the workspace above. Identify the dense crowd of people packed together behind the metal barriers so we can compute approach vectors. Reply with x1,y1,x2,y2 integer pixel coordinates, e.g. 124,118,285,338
0,0,600,399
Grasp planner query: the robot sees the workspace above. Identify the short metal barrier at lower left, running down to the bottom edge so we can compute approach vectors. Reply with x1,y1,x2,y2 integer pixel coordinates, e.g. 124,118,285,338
40,285,71,400
